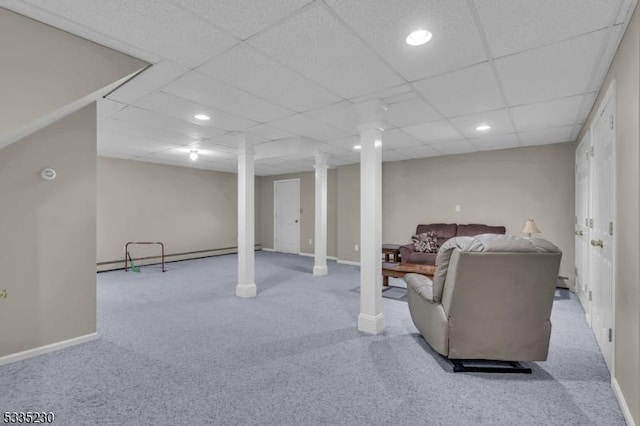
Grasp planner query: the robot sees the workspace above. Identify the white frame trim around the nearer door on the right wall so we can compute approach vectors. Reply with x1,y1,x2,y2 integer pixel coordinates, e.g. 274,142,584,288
589,79,619,377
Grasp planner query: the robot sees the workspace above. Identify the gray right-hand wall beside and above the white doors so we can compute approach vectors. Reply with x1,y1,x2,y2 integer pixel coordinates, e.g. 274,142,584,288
578,4,640,424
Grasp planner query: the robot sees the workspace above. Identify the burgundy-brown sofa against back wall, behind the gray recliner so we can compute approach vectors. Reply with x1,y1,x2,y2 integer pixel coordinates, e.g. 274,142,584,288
400,223,506,265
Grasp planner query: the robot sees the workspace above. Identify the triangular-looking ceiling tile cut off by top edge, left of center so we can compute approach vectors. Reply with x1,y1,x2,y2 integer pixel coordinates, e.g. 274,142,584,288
177,0,311,40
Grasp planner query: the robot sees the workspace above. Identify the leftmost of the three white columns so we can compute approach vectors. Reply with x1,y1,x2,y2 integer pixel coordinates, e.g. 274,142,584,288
236,135,257,297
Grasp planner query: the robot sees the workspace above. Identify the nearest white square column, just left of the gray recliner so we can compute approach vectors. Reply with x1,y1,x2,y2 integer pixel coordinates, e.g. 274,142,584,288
354,99,386,334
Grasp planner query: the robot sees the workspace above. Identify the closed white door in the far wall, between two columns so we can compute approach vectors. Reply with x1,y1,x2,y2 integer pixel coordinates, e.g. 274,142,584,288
273,179,300,254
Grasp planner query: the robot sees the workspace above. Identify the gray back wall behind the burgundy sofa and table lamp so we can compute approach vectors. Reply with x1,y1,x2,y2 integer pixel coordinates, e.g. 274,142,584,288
338,143,575,278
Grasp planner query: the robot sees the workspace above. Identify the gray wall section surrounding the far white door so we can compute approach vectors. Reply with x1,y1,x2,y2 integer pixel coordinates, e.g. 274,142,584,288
256,169,337,256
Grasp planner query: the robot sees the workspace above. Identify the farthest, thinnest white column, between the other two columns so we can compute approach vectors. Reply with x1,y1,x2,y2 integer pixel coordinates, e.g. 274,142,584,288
313,152,329,276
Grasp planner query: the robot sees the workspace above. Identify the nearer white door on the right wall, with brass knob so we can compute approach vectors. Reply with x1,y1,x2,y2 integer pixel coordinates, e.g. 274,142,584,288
589,86,616,370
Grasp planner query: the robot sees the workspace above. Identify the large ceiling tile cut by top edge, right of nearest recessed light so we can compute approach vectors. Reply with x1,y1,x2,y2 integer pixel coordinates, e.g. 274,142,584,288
475,0,619,57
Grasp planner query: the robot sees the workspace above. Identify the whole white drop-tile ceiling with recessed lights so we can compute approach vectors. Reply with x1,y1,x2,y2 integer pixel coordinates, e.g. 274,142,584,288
0,0,637,175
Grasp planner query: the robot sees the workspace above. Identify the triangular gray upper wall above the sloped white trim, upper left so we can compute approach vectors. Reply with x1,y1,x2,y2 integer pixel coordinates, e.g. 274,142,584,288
0,8,147,141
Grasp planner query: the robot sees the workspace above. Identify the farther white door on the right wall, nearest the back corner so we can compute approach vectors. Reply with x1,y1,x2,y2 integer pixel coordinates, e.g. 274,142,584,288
575,132,591,324
